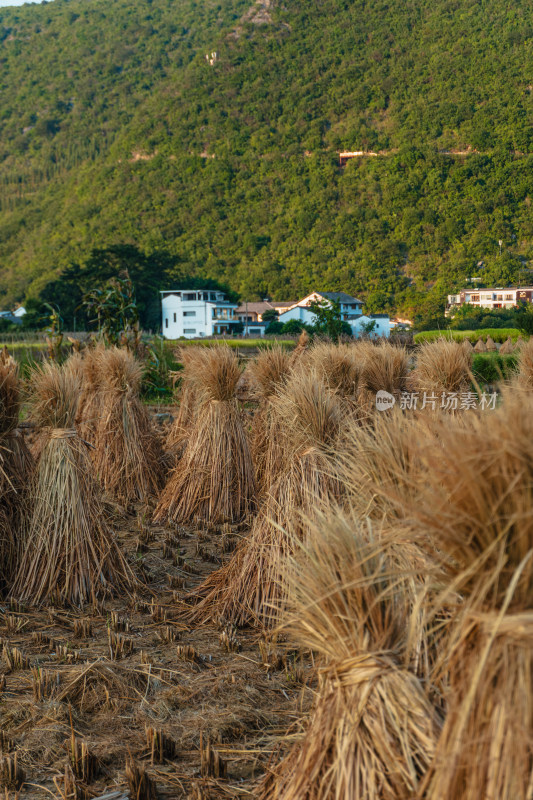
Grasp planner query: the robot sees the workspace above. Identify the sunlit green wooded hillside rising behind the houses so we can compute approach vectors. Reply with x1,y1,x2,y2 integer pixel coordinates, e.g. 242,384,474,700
0,0,533,324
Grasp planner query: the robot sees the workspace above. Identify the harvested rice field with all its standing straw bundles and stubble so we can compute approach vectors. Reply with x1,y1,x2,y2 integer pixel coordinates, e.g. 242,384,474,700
0,335,533,800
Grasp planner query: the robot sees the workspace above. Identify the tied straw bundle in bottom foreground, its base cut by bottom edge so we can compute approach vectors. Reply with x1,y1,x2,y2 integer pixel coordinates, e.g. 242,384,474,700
258,515,441,800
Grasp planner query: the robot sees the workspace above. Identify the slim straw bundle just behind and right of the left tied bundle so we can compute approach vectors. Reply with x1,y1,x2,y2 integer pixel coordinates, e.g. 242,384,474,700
94,347,163,503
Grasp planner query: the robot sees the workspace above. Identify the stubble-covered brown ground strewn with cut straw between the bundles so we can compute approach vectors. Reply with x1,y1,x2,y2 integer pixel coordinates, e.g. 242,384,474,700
0,410,311,800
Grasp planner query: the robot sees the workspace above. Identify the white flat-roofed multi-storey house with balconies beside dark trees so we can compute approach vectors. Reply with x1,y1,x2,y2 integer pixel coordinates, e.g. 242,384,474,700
161,289,240,339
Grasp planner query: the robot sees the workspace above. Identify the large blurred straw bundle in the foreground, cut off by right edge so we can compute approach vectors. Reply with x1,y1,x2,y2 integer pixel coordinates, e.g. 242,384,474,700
386,392,533,800
